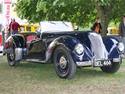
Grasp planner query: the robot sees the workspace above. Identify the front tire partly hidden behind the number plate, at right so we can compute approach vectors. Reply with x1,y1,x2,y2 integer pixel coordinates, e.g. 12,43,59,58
101,62,120,73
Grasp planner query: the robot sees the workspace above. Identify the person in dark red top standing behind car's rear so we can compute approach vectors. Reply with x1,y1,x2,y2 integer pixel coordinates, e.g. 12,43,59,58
9,19,20,35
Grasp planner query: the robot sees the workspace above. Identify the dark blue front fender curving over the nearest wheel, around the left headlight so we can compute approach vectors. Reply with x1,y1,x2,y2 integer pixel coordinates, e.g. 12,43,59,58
46,36,92,62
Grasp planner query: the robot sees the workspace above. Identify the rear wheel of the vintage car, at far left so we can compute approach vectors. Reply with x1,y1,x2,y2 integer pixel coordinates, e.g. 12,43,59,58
7,46,16,66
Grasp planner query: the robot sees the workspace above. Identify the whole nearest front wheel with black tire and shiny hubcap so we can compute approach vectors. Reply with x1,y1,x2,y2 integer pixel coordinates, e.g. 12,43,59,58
53,46,76,79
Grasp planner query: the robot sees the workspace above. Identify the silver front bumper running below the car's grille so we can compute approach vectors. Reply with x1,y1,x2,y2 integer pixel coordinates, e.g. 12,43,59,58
76,58,121,67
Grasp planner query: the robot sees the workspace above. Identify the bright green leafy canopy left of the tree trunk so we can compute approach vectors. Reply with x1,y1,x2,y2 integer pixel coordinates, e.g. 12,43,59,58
16,0,95,25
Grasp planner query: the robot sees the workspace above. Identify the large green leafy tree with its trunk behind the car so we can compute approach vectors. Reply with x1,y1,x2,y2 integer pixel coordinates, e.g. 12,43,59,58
16,0,125,35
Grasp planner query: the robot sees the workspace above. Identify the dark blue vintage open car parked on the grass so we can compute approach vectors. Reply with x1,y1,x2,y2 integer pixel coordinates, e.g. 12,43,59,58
4,21,124,79
